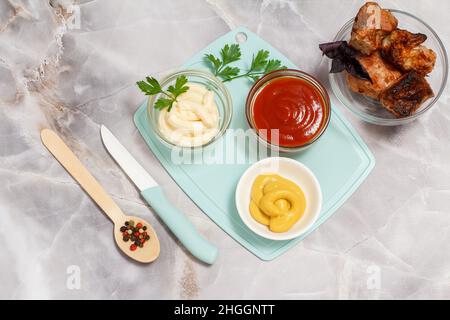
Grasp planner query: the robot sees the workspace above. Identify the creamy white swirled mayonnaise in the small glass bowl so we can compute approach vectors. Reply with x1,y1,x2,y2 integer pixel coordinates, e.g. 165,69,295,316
158,83,219,147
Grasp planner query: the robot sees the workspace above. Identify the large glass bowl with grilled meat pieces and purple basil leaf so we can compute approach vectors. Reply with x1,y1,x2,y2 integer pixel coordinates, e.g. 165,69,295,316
321,2,448,126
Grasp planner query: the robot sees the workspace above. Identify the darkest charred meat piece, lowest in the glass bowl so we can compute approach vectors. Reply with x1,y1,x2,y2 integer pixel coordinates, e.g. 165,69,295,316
380,71,434,118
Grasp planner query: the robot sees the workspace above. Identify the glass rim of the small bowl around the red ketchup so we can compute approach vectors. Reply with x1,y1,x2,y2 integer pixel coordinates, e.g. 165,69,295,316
245,69,331,153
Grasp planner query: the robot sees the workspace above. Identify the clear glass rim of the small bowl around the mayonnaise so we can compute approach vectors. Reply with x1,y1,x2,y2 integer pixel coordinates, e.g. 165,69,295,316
147,69,233,150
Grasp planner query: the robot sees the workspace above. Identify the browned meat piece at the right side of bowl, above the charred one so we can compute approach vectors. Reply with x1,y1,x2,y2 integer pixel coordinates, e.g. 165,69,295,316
382,29,436,76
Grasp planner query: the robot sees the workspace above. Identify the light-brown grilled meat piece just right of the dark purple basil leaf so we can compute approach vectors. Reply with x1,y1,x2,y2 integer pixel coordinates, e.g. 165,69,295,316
347,51,402,100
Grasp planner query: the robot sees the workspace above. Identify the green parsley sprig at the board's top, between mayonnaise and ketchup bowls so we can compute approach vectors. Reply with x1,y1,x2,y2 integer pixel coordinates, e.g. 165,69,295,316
204,44,286,82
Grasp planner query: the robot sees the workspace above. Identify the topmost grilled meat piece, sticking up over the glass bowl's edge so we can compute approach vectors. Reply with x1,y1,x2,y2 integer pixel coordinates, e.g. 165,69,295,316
350,2,398,55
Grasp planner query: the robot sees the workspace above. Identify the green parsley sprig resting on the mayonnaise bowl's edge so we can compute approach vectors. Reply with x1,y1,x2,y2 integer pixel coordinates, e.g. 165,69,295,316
136,76,189,112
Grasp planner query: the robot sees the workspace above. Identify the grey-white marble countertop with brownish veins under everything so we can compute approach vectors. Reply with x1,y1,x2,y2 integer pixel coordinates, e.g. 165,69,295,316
0,0,450,299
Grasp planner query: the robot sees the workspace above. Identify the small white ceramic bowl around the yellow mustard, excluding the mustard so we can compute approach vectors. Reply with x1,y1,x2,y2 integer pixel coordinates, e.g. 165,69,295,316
235,157,322,240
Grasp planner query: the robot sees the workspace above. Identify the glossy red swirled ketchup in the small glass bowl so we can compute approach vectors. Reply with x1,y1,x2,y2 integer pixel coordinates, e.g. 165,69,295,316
253,77,326,147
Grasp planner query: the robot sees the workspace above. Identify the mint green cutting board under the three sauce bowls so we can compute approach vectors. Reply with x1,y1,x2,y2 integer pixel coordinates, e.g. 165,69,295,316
134,28,375,260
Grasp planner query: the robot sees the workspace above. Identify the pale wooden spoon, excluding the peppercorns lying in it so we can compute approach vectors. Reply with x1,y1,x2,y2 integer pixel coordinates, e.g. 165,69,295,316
41,129,160,263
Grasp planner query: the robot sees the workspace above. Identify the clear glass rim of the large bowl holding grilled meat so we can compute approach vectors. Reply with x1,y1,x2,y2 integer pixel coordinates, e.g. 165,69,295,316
328,9,448,126
